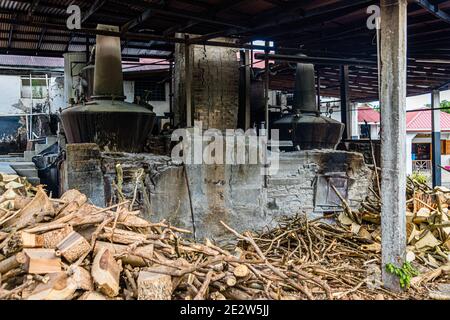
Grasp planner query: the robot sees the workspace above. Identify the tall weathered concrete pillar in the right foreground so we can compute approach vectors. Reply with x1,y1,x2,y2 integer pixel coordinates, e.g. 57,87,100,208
380,0,408,291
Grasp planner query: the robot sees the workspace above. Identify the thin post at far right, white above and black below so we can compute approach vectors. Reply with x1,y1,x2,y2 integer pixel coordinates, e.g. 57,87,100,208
431,90,442,187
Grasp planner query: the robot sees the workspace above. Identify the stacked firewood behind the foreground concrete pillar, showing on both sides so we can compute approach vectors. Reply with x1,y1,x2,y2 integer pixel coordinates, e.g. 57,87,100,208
346,178,450,268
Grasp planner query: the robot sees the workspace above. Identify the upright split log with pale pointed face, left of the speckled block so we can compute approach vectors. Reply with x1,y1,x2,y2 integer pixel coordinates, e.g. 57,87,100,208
91,248,121,298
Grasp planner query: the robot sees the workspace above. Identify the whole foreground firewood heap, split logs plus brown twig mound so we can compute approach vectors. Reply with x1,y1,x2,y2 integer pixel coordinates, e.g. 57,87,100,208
0,174,442,300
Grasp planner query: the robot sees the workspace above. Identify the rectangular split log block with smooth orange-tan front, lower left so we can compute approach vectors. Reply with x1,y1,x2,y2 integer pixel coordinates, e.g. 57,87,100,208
23,249,61,274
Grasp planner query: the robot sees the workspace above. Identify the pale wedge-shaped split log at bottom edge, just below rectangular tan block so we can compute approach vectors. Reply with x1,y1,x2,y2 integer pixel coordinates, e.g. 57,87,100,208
27,272,77,300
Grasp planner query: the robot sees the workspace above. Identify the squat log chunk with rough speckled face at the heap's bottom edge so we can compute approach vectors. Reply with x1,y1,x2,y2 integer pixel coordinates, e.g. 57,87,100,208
137,271,172,300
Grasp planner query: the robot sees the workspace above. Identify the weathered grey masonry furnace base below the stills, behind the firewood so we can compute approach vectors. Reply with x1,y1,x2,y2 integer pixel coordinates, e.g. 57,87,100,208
70,150,372,240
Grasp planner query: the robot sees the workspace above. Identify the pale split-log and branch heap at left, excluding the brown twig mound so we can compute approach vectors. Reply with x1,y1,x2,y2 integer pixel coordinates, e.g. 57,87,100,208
0,176,348,300
